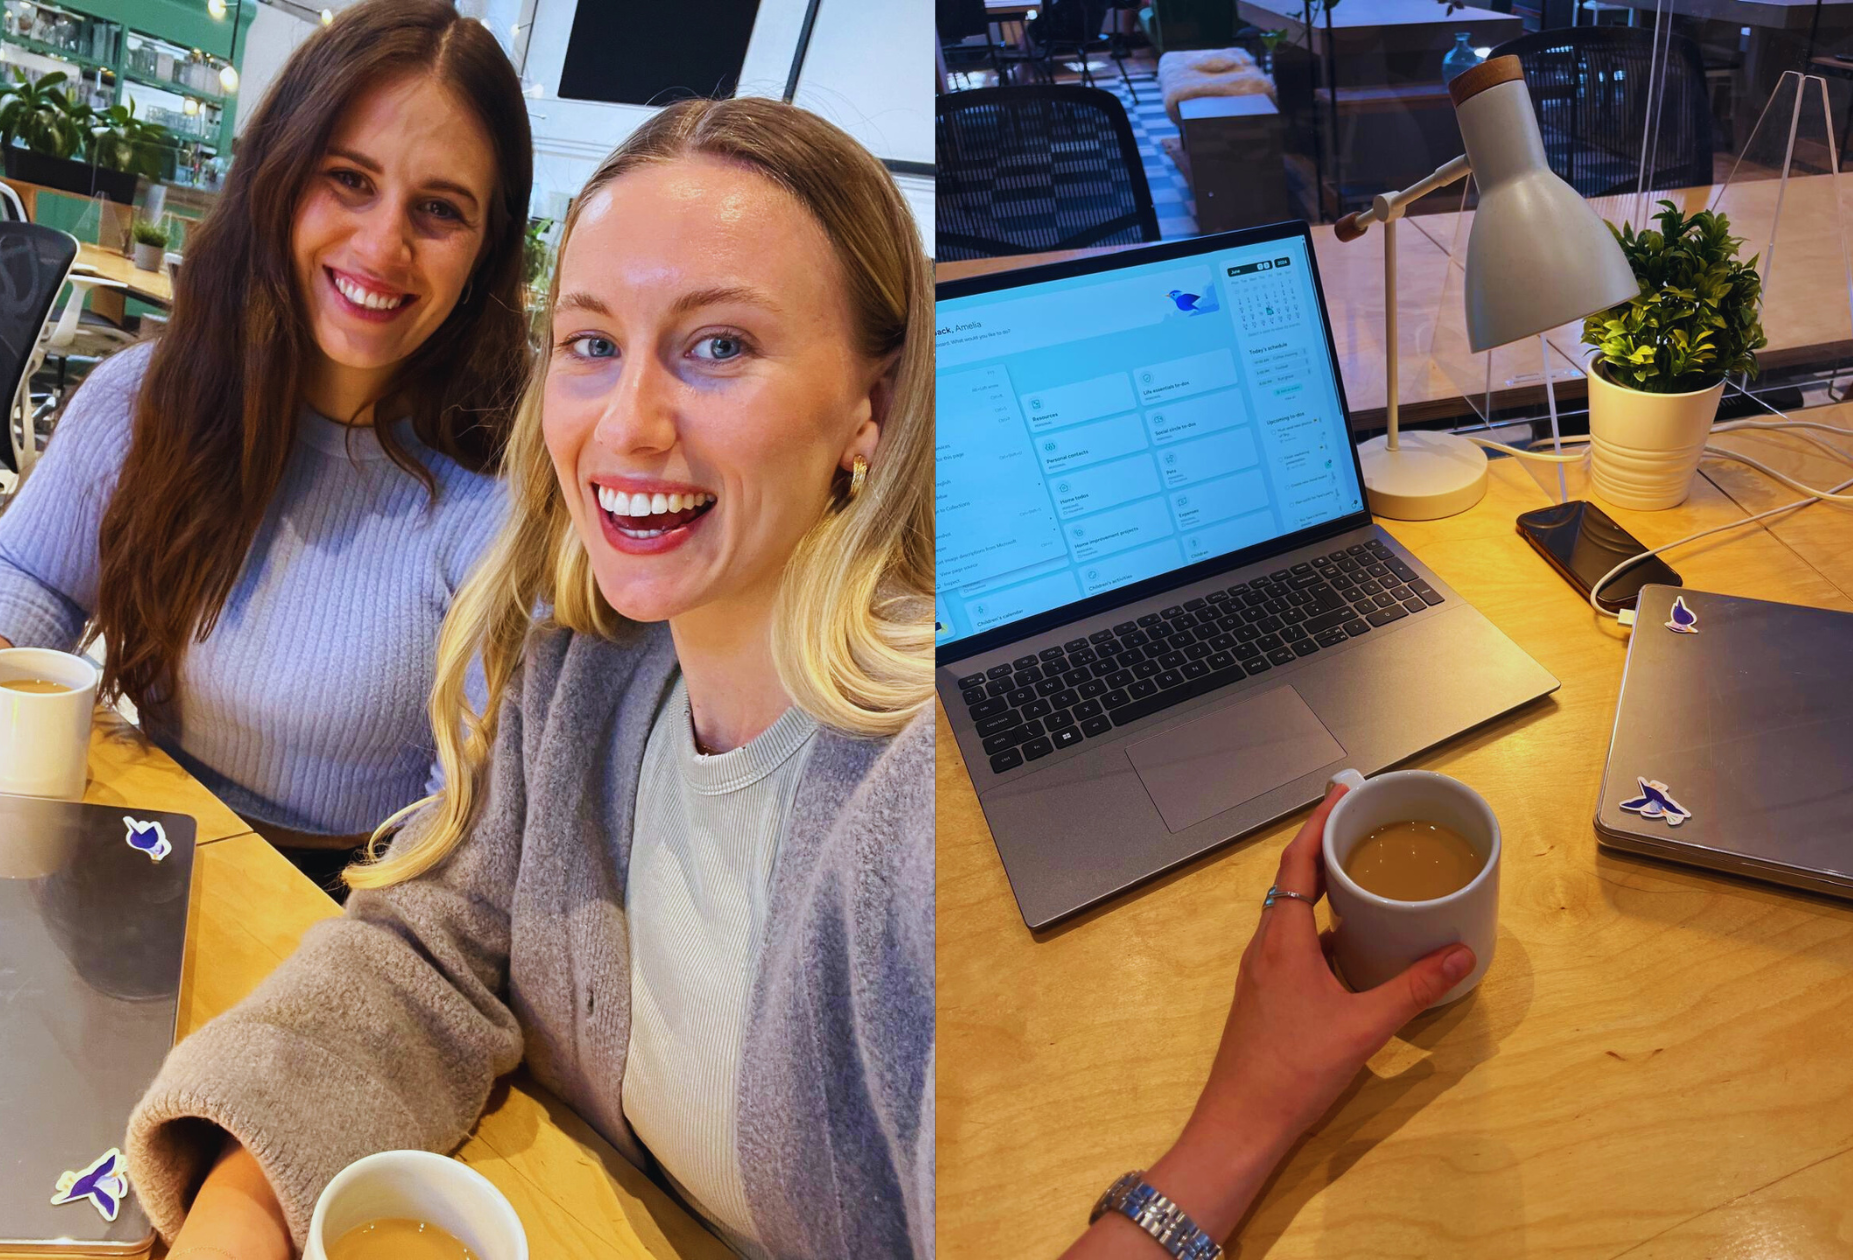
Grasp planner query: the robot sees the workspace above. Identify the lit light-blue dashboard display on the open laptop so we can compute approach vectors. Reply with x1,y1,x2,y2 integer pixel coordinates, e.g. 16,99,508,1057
934,237,1364,647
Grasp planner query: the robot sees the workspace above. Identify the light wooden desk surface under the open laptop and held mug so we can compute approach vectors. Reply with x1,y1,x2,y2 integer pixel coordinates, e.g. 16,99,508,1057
938,429,1853,1260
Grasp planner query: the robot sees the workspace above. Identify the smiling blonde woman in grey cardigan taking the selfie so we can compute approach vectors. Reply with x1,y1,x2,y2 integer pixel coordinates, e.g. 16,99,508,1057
128,100,934,1260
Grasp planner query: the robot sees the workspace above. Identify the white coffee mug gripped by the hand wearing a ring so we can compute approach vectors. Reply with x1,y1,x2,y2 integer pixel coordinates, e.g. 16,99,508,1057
1325,771,1499,1010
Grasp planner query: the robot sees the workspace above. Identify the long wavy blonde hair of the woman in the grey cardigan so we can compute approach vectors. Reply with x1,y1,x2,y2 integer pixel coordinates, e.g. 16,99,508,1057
347,98,934,888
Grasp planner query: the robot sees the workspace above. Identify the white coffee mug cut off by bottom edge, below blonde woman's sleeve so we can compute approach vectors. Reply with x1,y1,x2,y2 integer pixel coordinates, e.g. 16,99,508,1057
302,1151,528,1260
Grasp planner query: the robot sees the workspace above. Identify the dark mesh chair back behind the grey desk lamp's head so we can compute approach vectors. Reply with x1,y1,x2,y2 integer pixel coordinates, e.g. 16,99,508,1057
1494,26,1712,196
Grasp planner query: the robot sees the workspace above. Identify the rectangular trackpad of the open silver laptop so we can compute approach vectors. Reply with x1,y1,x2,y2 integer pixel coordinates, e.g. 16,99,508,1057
1127,687,1345,832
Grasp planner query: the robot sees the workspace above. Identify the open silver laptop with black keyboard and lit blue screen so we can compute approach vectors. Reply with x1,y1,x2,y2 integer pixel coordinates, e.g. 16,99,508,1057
936,222,1557,928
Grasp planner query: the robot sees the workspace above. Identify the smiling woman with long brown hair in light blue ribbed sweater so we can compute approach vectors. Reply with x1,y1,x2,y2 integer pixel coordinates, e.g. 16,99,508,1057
0,0,534,885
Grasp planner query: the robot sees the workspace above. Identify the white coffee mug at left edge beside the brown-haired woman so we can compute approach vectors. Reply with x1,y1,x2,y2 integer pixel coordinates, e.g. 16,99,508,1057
0,647,100,800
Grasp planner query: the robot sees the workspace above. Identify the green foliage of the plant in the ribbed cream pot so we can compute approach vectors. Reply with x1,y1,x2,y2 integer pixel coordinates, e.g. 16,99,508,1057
1582,202,1768,393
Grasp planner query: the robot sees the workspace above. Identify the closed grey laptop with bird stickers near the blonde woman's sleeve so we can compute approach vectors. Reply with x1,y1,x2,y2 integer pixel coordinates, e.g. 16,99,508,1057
0,797,195,1256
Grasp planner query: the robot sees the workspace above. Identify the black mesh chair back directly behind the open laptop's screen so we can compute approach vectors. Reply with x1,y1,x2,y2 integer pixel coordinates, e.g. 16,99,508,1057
934,83,1158,259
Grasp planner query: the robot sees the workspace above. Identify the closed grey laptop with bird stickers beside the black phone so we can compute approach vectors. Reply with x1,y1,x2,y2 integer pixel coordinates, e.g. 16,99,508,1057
1595,586,1853,897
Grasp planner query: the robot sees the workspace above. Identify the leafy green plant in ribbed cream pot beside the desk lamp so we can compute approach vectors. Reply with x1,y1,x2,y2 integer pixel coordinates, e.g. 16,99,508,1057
1582,202,1766,510
